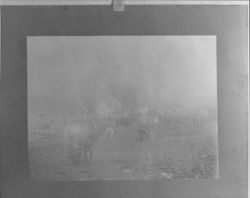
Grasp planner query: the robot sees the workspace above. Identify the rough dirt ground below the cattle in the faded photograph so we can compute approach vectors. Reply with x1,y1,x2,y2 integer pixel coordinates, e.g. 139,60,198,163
29,120,218,181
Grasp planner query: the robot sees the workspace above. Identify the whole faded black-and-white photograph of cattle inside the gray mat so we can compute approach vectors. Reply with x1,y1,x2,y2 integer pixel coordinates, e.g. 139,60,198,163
27,35,219,181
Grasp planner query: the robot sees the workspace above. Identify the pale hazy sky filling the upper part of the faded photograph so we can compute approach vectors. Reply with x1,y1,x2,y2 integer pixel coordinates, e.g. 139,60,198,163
27,36,217,113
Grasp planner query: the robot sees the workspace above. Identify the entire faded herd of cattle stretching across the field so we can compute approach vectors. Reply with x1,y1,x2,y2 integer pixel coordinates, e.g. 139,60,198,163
63,108,213,165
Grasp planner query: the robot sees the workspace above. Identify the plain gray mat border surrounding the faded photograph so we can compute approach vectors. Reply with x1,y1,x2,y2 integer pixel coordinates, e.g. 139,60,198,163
1,5,248,198
